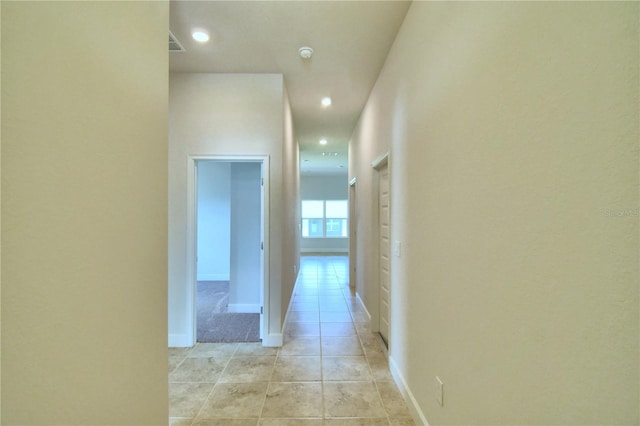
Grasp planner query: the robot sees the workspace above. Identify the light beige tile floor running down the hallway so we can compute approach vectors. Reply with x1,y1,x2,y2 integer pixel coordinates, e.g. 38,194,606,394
169,256,414,426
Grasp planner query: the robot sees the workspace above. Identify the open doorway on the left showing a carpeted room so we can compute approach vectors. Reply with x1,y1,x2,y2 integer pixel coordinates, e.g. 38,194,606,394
190,157,266,342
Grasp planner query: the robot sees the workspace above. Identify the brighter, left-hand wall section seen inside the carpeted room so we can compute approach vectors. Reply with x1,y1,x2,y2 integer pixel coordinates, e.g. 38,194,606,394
197,161,231,281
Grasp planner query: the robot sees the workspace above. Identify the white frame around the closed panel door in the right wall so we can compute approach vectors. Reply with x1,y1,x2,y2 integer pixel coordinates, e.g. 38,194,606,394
371,151,392,349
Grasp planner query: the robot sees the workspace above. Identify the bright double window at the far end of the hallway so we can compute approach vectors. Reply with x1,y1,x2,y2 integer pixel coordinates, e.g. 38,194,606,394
302,200,349,238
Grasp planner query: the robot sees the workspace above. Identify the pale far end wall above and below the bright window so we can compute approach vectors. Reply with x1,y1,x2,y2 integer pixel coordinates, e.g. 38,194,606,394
300,174,349,253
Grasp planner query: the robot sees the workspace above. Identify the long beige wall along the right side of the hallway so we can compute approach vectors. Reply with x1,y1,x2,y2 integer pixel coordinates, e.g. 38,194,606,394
350,2,640,424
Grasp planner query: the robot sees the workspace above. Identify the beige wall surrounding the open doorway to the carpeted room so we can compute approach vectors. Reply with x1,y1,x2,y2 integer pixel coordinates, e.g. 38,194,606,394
169,73,298,346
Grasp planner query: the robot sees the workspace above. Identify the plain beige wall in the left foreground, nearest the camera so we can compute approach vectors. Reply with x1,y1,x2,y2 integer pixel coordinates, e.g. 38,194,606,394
1,1,169,425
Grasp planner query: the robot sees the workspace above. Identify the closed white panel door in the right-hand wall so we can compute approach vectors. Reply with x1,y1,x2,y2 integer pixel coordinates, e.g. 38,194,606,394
378,164,390,346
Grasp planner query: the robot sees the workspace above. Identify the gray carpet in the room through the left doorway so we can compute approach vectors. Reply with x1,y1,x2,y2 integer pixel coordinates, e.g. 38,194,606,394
196,281,260,343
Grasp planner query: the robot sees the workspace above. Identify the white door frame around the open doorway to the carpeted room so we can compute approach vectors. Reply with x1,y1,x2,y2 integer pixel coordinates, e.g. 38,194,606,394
186,154,270,346
